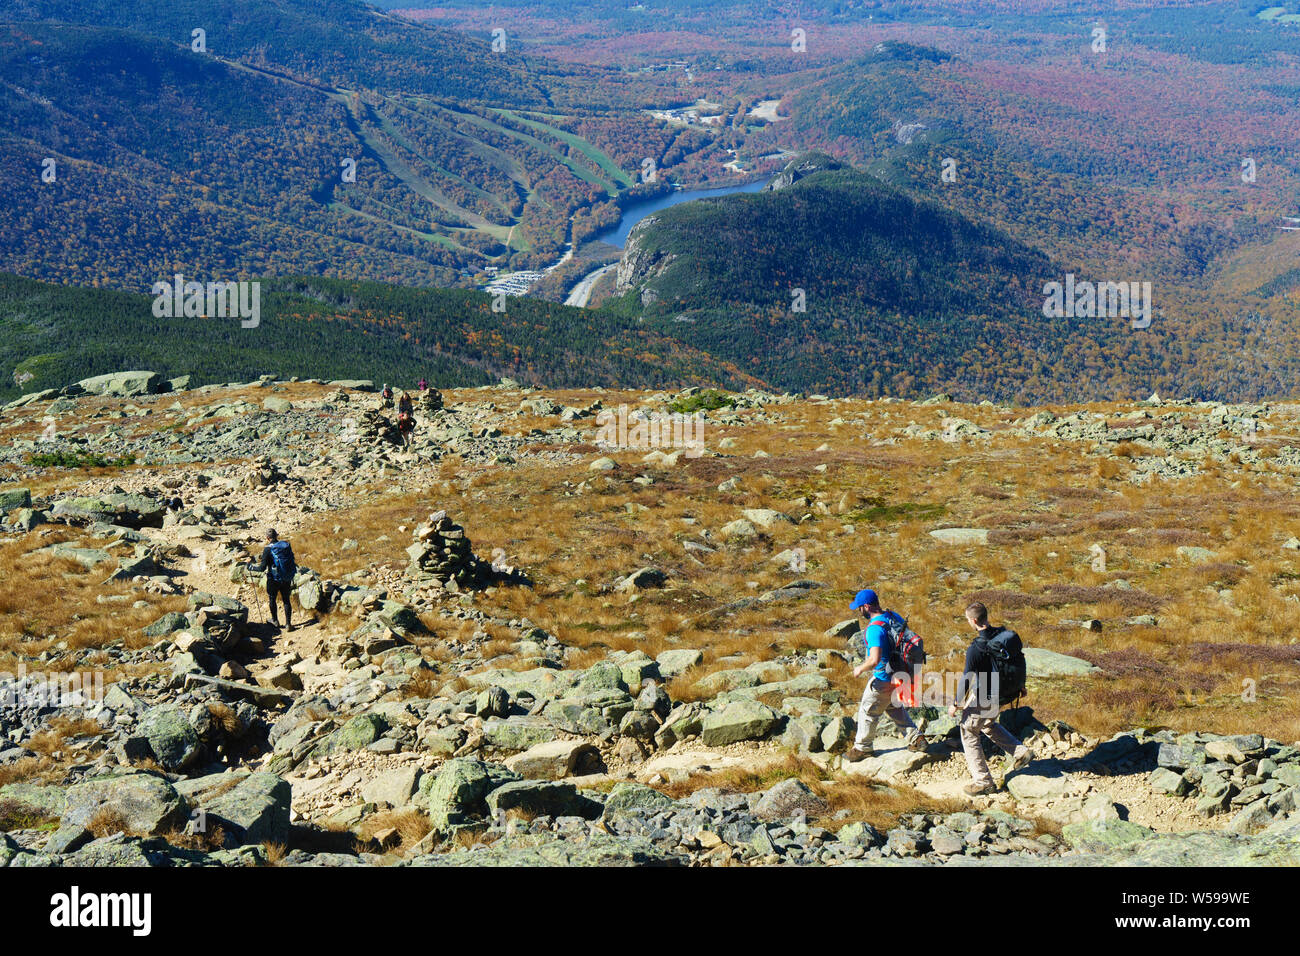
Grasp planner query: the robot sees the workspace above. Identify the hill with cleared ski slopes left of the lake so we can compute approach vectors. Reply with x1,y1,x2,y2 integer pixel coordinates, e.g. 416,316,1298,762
0,0,698,290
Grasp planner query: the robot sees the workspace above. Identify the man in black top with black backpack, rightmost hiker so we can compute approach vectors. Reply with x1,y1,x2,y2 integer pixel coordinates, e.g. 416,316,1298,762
948,601,1034,796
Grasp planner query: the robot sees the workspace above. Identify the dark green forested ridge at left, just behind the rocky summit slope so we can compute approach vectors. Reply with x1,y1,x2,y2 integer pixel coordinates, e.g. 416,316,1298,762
0,273,754,398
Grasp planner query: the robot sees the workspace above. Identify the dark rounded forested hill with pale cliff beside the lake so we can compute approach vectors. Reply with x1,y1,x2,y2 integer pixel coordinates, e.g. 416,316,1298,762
608,157,1180,401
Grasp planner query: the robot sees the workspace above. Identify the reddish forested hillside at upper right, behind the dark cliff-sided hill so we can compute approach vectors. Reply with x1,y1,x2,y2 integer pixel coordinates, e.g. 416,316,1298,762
780,40,1300,284
